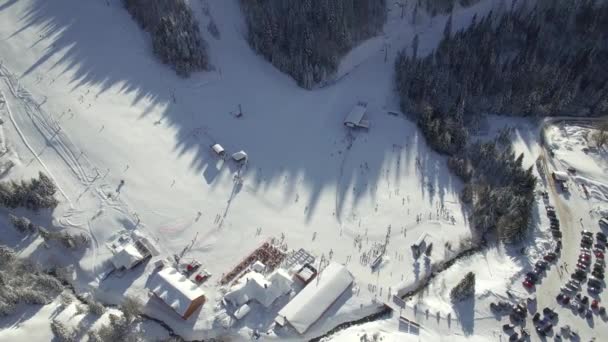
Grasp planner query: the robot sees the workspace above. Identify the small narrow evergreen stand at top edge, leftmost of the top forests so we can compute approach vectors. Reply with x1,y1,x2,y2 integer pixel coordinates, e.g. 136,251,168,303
123,0,209,76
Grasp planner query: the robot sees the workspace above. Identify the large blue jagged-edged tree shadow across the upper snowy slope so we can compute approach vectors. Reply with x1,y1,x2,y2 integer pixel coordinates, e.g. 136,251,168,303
3,0,460,221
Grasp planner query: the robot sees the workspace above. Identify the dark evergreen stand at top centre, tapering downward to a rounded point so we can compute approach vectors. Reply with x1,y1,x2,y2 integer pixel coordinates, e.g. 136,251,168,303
241,0,386,89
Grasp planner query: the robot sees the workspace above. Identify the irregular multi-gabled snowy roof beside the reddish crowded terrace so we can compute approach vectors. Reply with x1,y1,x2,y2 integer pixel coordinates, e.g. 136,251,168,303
224,269,293,307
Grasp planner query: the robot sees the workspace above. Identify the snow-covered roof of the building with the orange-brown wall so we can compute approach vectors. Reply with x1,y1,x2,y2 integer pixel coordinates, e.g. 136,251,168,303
147,267,205,317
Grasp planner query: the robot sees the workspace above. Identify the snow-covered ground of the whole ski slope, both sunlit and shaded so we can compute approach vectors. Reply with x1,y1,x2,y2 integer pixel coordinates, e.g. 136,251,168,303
0,0,588,340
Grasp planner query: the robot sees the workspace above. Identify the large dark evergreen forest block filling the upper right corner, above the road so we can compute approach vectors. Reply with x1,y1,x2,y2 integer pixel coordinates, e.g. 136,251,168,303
396,0,608,154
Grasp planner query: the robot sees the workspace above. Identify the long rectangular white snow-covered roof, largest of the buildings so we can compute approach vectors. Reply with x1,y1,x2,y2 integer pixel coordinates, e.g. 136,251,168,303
277,262,353,334
